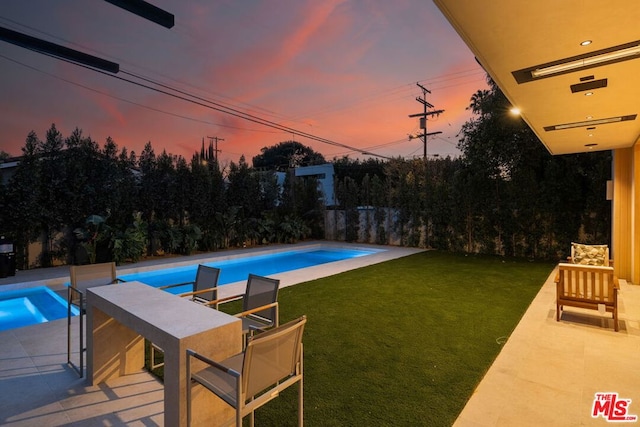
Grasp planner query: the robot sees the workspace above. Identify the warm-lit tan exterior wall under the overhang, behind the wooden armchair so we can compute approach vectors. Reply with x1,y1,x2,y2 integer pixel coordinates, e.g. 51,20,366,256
611,142,640,284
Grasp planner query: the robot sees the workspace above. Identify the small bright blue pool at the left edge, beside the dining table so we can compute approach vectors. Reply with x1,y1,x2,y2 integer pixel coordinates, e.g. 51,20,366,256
0,286,78,331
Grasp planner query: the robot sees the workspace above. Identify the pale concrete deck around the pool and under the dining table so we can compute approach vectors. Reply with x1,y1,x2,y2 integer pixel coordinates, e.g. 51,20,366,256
0,242,422,426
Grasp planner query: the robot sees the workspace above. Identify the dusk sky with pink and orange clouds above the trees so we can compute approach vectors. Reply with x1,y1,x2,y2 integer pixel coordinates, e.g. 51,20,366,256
0,0,486,164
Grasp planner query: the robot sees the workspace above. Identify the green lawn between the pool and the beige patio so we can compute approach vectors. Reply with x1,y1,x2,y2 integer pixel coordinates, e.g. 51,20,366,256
245,251,554,427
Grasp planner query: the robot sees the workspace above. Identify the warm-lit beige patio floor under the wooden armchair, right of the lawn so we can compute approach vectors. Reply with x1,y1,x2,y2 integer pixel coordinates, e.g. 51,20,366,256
454,271,640,427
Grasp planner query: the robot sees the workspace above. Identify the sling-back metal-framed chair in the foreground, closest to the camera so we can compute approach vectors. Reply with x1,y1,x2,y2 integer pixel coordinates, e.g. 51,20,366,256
187,316,307,427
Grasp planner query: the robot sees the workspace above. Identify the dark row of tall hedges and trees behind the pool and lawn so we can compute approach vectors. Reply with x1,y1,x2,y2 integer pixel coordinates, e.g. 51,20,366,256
0,77,611,268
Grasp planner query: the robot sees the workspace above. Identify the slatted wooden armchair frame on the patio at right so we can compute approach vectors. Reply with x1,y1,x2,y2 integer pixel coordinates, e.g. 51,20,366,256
555,263,620,332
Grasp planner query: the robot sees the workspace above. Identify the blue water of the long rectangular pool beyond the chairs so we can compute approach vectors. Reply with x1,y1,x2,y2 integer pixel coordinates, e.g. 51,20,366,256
118,248,379,294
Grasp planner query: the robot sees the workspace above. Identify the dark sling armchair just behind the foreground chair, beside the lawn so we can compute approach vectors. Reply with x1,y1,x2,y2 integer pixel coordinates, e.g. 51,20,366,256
206,274,280,343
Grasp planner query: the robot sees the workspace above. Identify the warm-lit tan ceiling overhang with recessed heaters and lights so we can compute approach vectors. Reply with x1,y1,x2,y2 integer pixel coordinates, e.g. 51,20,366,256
434,0,640,154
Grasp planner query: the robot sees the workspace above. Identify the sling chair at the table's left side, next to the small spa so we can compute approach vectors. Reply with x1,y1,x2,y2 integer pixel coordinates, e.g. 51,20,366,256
67,262,123,377
